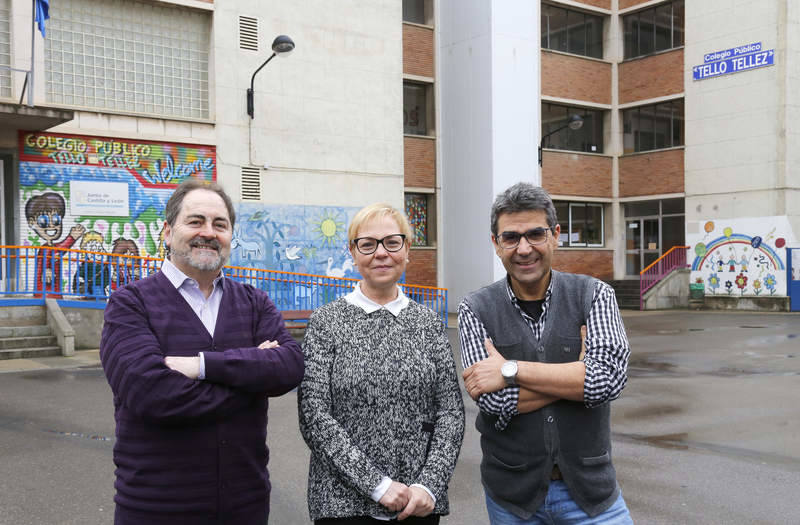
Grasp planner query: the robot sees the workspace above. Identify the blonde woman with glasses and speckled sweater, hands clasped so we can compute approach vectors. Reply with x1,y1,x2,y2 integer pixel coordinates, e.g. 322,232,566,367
298,204,464,525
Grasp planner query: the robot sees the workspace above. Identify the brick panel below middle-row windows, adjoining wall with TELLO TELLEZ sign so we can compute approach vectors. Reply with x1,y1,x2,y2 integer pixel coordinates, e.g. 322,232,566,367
619,148,688,198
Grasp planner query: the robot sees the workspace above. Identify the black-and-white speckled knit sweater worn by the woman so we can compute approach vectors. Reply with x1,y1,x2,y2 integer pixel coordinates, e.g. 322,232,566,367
298,298,464,520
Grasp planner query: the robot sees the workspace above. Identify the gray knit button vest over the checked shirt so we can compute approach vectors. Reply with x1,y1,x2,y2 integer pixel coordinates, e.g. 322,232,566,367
466,271,619,519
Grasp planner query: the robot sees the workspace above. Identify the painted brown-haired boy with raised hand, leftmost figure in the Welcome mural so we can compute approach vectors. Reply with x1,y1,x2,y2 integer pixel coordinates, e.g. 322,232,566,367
25,192,86,297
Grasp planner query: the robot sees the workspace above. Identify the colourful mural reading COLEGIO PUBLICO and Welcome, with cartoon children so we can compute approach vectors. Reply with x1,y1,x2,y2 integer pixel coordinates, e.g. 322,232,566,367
19,132,217,294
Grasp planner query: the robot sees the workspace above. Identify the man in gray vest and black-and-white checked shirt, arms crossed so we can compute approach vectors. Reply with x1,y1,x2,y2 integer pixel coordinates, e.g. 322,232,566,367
458,183,633,525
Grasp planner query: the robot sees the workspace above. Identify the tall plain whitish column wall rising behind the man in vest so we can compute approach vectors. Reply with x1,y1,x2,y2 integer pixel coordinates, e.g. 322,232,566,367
437,0,541,304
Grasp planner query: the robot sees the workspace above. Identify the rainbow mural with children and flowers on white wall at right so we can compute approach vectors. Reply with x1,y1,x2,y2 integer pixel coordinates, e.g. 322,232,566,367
686,216,796,296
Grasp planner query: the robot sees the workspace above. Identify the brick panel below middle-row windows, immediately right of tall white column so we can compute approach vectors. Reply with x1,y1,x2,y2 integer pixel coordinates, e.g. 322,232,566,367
542,151,613,197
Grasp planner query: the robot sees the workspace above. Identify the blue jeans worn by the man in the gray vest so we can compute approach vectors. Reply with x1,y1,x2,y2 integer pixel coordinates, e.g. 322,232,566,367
486,481,633,525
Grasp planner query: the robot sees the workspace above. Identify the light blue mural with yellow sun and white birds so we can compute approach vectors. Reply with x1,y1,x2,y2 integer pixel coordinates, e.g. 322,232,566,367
230,203,359,278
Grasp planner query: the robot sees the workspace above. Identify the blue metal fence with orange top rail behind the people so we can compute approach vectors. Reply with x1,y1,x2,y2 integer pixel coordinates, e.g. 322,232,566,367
0,246,447,325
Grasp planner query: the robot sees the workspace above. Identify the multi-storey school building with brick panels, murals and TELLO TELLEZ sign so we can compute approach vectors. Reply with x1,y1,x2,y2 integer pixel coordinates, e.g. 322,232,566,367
0,0,800,311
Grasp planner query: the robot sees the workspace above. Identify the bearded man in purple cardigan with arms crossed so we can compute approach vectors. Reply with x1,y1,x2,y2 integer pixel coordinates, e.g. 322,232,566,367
100,178,304,525
